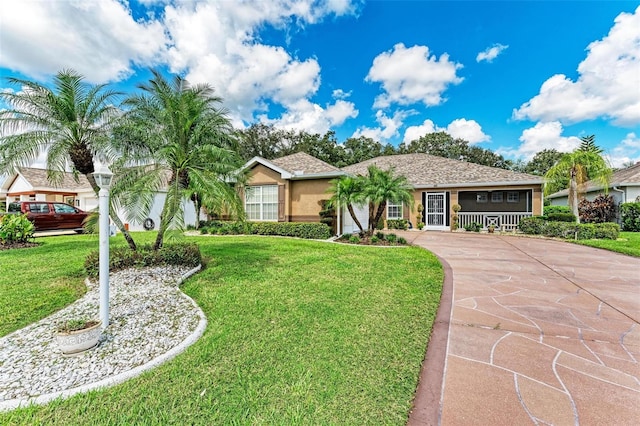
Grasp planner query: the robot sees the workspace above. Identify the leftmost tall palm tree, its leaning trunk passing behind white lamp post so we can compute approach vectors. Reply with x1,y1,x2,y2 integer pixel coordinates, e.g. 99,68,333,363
0,70,136,250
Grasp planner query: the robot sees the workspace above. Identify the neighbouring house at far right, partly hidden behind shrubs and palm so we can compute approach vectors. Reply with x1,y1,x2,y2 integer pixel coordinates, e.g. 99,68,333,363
547,162,640,211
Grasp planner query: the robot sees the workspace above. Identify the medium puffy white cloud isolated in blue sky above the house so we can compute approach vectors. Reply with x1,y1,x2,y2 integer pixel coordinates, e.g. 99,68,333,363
366,43,463,109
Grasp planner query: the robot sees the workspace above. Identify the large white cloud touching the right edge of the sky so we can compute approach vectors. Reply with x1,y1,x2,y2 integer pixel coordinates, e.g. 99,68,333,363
513,7,640,125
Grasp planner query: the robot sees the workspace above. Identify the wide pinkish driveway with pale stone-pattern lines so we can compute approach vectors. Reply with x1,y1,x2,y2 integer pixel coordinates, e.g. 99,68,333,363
402,232,640,425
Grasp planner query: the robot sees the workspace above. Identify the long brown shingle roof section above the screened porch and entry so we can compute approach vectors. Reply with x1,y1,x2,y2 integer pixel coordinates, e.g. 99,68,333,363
342,154,542,187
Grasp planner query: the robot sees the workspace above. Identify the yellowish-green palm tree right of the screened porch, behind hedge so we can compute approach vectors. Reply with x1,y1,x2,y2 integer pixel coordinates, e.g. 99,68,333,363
544,149,611,223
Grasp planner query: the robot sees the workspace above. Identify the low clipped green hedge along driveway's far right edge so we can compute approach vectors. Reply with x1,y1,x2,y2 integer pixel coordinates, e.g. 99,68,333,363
518,216,620,240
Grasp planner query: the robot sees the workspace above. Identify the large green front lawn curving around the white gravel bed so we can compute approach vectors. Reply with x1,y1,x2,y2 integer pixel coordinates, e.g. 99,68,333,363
0,234,443,425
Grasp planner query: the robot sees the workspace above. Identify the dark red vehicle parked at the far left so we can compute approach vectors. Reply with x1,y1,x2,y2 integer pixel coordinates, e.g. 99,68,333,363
7,201,89,232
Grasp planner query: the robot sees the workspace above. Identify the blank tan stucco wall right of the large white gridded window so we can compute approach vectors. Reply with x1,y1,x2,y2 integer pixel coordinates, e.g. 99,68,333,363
289,179,331,222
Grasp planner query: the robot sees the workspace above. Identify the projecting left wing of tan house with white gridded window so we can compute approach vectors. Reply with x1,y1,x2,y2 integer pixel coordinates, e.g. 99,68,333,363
243,152,345,222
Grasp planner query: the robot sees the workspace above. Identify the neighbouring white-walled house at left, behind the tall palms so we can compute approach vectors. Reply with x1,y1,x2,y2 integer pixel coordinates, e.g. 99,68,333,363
0,167,206,231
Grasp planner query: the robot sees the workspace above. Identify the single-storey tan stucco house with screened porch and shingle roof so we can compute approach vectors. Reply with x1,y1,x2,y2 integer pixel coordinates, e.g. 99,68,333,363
245,153,543,233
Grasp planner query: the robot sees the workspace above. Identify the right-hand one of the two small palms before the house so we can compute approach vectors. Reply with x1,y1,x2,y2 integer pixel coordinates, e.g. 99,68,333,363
363,165,414,233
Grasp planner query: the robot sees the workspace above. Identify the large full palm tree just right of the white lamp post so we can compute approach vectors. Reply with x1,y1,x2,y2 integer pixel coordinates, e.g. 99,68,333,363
117,70,243,250
